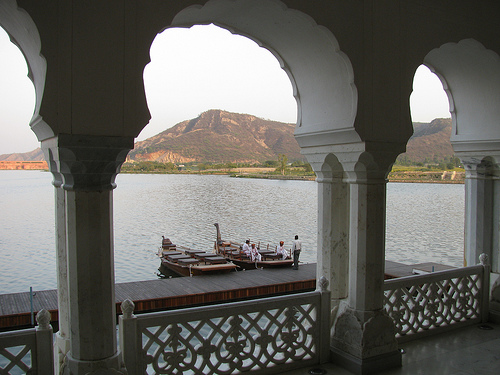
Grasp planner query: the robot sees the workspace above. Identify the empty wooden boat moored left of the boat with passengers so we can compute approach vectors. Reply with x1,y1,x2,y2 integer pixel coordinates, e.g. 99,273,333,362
158,236,237,276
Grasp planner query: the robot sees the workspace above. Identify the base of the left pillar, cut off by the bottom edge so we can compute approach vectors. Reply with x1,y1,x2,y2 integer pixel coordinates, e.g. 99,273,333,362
63,352,128,375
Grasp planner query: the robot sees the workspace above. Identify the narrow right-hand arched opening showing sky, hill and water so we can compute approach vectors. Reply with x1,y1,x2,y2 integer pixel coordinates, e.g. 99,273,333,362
386,65,464,267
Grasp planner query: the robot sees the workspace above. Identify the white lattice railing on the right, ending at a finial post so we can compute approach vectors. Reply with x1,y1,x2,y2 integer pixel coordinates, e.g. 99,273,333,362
384,258,490,342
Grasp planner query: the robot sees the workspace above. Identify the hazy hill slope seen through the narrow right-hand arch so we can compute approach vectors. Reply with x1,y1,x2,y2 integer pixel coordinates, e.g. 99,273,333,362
398,118,455,162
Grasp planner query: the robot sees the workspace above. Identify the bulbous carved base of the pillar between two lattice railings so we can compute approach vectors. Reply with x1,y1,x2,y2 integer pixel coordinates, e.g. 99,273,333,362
330,303,401,374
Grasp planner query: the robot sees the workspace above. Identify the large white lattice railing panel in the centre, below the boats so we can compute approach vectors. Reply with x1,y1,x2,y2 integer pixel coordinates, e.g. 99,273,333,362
132,295,320,374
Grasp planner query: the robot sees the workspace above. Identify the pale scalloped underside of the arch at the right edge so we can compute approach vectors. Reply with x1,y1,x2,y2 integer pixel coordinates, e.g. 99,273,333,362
424,39,500,151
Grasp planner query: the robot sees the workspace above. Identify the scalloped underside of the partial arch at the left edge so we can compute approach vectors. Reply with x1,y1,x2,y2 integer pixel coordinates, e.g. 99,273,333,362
0,0,54,141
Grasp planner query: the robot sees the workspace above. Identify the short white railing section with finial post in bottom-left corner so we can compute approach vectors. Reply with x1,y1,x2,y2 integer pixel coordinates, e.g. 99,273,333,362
0,310,54,375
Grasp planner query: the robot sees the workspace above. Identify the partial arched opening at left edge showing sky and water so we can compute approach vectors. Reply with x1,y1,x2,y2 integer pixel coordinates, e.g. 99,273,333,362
0,27,56,294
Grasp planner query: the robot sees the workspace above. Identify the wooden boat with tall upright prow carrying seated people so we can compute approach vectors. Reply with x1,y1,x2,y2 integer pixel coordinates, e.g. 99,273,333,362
214,223,293,270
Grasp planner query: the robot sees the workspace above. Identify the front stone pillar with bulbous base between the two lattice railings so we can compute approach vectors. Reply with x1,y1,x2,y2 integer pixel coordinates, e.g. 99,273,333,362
331,152,401,374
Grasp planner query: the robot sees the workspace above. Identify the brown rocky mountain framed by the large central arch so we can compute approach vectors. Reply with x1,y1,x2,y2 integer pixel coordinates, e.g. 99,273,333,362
129,109,304,163
